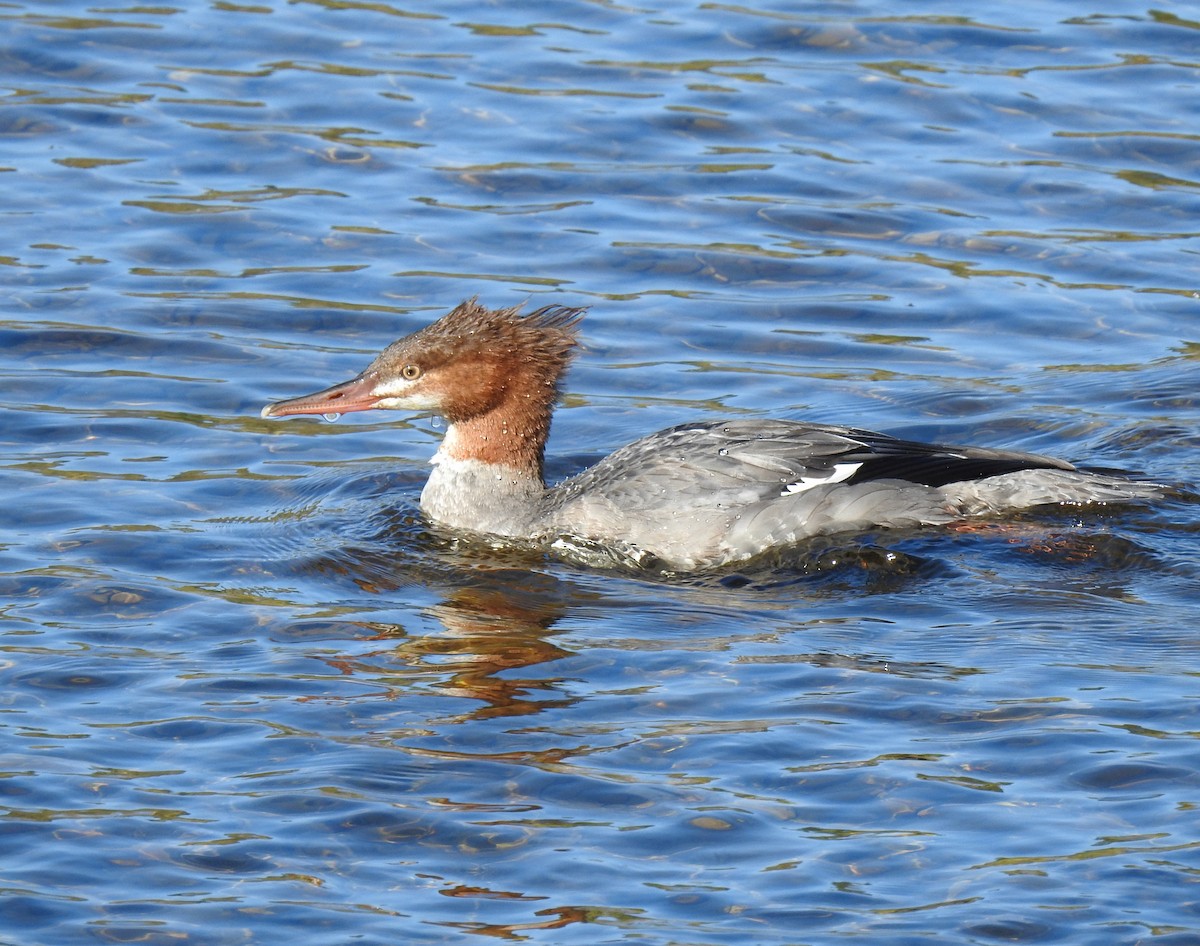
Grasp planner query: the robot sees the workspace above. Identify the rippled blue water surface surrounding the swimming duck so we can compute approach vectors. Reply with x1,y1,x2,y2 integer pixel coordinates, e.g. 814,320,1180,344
0,0,1200,946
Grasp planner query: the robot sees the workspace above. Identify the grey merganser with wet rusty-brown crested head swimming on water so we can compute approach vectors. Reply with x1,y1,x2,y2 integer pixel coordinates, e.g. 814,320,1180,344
262,299,1162,571
